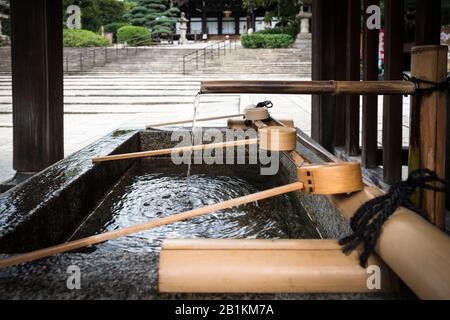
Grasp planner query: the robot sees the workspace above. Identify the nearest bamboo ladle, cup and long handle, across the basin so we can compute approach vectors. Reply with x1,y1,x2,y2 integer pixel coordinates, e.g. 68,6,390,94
0,163,363,268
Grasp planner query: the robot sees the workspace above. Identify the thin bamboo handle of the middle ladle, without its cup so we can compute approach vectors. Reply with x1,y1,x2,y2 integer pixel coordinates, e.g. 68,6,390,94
92,139,258,163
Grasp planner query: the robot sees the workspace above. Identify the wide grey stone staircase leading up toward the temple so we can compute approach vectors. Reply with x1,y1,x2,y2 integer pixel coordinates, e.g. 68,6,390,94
0,45,311,77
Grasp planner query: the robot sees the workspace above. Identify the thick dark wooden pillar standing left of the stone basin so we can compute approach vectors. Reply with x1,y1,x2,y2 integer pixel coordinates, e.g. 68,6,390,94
11,0,64,172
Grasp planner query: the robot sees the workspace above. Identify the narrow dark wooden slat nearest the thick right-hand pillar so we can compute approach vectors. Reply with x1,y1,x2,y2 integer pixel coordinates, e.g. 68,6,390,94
345,0,361,156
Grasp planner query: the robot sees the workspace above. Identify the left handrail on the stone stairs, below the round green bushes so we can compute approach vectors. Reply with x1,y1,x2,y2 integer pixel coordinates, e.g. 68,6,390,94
64,36,149,73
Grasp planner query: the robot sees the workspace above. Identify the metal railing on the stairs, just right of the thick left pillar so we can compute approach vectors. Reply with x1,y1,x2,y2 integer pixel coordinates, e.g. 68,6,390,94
64,37,150,73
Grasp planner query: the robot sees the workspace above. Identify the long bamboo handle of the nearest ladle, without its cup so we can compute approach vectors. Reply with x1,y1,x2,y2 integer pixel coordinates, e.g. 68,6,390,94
0,182,303,269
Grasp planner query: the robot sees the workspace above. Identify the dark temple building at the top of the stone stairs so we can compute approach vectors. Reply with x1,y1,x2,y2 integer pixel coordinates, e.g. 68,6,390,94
174,0,277,37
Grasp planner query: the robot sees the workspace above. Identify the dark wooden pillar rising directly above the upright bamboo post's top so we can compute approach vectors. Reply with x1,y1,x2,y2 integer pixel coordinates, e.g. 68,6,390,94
416,0,441,46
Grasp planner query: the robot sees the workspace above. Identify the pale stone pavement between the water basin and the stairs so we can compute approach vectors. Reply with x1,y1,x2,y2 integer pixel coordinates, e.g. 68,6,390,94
0,73,310,181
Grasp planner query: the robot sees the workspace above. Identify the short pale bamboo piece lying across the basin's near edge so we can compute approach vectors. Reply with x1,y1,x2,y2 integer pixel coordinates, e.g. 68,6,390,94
158,239,398,293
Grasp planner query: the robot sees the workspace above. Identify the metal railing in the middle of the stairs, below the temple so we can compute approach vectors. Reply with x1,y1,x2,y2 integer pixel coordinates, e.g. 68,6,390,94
183,39,237,74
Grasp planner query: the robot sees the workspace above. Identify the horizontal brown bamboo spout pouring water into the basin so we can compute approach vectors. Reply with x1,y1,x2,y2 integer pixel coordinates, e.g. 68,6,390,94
200,80,416,95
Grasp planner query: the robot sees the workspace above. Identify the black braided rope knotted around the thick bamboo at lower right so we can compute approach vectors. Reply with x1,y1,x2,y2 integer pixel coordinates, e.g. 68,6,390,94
339,169,446,268
